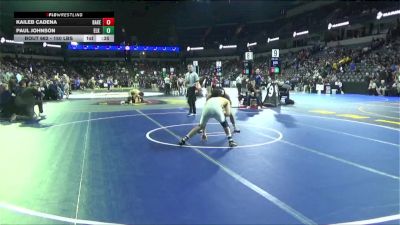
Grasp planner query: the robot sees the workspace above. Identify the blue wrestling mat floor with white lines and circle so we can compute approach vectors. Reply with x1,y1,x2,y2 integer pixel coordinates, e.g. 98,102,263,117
0,90,400,224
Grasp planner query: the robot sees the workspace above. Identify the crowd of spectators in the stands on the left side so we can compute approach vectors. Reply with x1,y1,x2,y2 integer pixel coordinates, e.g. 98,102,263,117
0,57,181,90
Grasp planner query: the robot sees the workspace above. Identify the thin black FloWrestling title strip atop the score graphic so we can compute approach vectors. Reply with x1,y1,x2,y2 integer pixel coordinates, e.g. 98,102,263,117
14,12,114,18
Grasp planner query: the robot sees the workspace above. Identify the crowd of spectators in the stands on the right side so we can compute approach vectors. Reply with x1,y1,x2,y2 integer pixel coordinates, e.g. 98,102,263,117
268,39,400,95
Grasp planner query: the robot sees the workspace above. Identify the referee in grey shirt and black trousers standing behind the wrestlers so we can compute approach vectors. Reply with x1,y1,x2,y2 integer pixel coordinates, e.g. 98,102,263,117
185,64,199,116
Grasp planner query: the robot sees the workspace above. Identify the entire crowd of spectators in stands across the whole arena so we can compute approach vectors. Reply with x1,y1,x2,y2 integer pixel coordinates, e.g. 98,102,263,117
0,34,400,105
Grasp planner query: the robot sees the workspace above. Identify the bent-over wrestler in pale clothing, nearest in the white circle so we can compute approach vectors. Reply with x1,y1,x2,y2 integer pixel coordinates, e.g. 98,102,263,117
179,97,237,147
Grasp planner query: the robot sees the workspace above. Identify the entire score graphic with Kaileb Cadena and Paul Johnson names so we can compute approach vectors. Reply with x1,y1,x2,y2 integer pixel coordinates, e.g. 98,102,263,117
14,12,115,42
